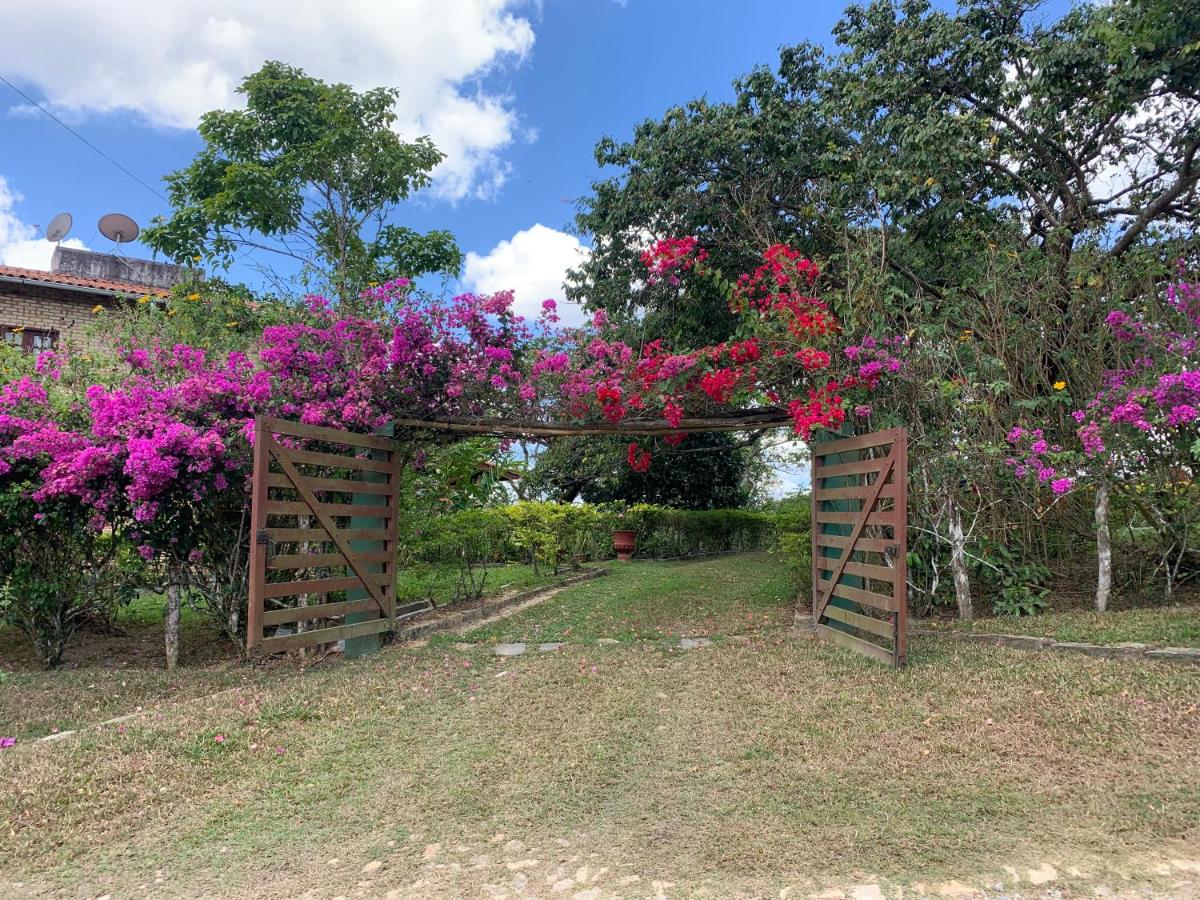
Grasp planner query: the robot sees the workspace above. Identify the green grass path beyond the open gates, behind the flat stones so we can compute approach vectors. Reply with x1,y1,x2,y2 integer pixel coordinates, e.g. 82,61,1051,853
460,554,794,643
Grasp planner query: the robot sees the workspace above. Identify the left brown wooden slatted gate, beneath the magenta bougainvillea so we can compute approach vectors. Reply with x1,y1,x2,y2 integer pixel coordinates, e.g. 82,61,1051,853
246,416,401,653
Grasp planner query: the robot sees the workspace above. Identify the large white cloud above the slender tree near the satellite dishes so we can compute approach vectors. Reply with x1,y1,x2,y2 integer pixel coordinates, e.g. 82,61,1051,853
0,0,534,199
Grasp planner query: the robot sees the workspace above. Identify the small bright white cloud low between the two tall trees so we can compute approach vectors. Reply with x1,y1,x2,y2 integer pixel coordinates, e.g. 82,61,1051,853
463,223,588,325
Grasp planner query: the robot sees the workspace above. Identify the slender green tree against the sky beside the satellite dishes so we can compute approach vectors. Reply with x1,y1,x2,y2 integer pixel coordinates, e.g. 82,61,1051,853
143,61,462,302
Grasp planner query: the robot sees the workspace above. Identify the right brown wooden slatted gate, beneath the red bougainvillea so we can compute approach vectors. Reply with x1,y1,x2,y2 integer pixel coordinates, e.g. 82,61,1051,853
812,428,908,667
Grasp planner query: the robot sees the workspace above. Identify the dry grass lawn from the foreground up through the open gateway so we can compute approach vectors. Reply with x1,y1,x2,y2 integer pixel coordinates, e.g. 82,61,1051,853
0,557,1200,899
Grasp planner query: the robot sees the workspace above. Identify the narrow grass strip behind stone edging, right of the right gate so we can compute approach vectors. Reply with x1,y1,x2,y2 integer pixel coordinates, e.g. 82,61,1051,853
928,606,1200,647
